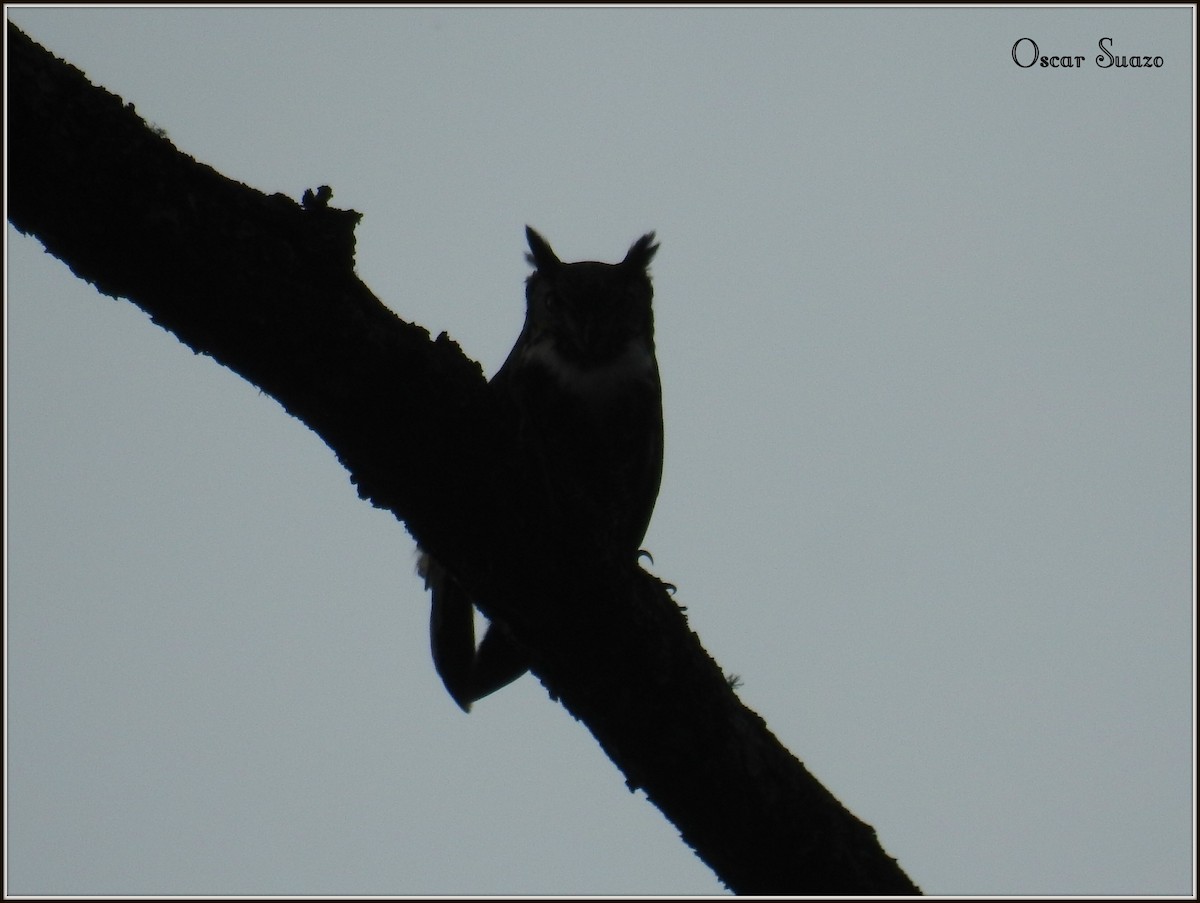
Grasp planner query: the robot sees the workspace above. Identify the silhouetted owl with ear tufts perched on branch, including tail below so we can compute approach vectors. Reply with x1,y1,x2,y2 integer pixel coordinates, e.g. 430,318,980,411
418,227,662,711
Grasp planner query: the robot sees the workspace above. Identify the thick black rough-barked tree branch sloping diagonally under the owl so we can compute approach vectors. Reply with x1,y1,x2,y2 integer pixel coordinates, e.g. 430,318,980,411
7,23,919,895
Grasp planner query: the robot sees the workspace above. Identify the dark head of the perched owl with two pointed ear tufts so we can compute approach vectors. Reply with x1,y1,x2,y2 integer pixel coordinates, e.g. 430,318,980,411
524,226,659,376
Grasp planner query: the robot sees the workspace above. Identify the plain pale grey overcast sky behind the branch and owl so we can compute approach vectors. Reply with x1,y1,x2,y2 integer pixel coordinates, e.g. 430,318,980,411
6,7,1195,896
